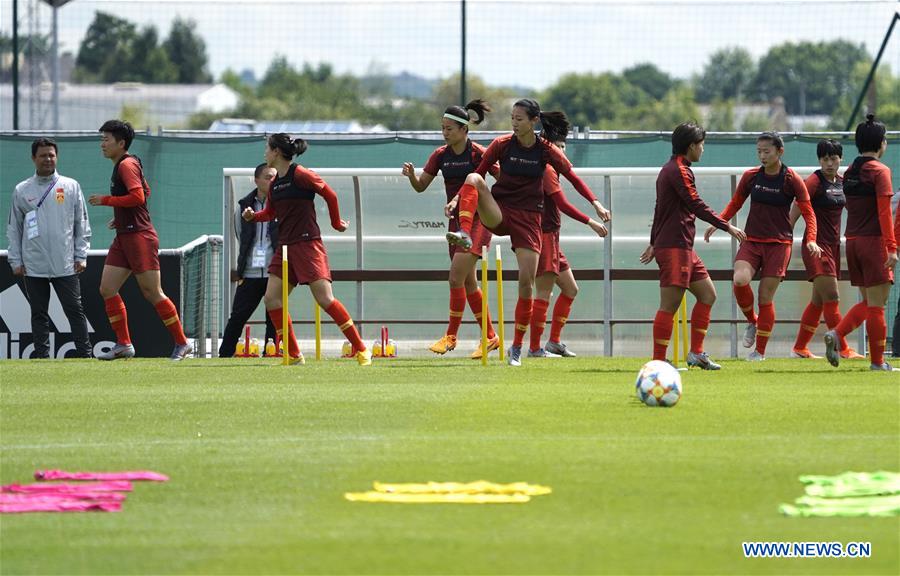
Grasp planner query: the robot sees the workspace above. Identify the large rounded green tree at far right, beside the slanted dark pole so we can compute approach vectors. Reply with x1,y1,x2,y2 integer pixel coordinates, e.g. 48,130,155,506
755,40,871,115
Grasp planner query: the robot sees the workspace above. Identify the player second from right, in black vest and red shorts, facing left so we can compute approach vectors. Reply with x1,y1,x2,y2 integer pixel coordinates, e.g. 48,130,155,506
791,139,864,358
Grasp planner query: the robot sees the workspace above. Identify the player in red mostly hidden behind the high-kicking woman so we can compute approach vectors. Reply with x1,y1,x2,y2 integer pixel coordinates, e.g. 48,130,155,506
528,134,609,358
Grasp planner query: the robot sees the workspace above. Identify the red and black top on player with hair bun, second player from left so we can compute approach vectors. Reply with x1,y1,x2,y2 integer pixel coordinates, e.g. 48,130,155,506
253,164,341,245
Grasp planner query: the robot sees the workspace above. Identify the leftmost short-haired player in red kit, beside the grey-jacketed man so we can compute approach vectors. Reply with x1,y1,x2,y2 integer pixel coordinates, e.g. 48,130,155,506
88,120,193,362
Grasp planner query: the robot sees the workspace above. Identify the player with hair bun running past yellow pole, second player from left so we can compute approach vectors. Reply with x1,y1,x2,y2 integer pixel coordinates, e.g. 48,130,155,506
243,133,372,366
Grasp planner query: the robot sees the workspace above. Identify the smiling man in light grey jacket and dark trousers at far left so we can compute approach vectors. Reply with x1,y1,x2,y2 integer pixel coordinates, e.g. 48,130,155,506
6,138,91,358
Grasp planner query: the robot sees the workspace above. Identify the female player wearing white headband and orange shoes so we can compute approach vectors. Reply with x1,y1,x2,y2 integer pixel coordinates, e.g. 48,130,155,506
403,100,500,360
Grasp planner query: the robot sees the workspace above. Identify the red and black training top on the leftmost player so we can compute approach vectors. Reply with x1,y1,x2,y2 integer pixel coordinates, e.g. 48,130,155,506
100,154,153,234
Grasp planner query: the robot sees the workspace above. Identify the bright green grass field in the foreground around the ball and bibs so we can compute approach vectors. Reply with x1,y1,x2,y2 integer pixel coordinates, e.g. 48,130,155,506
0,358,900,574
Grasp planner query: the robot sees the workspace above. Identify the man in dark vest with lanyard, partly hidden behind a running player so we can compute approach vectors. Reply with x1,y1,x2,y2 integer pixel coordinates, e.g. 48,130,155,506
219,164,278,358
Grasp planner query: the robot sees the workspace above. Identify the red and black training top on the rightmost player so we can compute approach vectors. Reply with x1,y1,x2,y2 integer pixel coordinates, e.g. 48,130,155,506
844,156,897,252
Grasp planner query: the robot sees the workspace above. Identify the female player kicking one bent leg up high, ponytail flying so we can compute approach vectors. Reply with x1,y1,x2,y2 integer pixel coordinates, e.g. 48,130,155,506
447,99,608,366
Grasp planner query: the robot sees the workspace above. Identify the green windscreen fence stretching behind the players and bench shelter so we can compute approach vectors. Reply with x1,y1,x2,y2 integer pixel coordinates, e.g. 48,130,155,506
0,134,900,248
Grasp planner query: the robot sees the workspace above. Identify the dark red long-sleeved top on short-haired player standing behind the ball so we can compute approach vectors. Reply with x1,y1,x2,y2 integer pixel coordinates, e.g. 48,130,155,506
650,154,728,249
